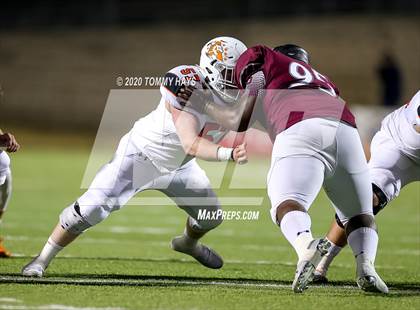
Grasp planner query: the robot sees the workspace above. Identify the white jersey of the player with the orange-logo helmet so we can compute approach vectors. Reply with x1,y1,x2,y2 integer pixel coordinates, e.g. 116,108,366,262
130,65,228,172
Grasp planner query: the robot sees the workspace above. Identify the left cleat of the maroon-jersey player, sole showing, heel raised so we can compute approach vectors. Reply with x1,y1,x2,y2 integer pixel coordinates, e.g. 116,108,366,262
292,239,331,293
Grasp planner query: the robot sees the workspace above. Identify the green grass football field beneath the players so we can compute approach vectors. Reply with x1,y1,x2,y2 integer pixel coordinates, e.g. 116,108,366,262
0,143,420,310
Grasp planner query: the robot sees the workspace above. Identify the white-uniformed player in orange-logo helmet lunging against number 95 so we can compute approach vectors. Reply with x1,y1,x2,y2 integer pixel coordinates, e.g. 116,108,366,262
22,37,247,277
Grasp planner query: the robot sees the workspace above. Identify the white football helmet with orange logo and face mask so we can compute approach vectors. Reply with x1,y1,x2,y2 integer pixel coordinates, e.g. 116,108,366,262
200,37,247,102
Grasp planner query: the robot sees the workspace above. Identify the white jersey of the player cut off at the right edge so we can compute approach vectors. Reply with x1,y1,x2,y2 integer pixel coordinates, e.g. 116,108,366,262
381,91,420,163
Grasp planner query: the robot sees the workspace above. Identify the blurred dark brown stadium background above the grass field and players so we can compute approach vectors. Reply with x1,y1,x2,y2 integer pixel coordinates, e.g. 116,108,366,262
0,0,420,133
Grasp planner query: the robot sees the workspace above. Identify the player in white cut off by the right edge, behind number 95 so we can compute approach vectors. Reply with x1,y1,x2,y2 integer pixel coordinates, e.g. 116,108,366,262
314,91,420,282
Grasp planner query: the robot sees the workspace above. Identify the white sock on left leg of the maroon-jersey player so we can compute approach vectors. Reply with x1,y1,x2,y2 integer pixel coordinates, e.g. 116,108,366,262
280,211,313,260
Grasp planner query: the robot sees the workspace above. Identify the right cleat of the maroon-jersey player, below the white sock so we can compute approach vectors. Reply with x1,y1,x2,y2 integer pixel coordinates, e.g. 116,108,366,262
356,254,389,294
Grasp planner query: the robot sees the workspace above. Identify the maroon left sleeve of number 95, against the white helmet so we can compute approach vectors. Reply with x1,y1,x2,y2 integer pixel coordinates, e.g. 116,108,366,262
235,45,265,89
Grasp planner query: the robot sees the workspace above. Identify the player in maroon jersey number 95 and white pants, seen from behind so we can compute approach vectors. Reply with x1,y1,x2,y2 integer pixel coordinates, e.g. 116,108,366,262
180,45,388,293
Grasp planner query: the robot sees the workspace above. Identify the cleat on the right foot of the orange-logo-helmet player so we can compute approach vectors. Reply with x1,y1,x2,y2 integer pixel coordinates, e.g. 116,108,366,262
171,236,223,269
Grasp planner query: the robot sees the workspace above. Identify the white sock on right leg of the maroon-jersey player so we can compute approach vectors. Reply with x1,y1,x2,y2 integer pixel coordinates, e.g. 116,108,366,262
347,227,378,264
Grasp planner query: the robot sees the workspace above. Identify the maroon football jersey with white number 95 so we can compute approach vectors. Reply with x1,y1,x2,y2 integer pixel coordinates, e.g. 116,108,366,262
235,45,356,140
